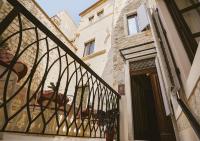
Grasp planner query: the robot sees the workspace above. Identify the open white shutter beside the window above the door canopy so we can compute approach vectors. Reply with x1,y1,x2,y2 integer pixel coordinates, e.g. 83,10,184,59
137,4,149,31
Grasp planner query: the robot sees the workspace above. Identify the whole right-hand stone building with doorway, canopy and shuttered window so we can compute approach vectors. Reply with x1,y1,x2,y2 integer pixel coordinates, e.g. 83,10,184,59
112,0,200,141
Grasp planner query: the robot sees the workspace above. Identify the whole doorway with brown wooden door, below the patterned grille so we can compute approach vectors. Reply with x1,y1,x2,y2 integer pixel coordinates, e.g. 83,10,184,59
130,68,176,141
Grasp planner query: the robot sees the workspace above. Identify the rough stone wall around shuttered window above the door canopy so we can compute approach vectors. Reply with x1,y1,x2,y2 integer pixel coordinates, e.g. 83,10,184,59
112,0,152,90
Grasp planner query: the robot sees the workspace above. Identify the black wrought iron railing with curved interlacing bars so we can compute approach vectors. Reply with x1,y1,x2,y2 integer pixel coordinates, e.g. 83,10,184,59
0,0,120,139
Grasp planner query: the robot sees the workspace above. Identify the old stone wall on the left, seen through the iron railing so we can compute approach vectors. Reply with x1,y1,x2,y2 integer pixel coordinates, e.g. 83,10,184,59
0,0,83,140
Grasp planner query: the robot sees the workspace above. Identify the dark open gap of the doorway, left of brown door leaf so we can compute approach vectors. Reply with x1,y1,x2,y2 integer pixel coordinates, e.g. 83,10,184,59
131,75,160,141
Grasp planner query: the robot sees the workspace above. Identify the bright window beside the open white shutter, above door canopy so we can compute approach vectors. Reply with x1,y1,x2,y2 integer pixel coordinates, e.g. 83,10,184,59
127,14,139,35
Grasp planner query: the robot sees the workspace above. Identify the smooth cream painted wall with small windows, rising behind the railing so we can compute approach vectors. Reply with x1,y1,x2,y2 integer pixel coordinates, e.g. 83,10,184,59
76,0,113,84
